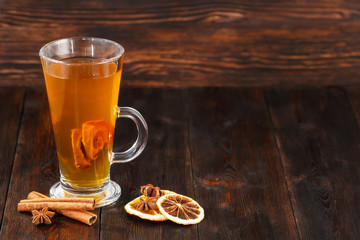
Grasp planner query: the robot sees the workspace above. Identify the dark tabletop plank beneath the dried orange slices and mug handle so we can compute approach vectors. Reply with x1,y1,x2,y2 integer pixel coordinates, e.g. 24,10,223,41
100,89,197,239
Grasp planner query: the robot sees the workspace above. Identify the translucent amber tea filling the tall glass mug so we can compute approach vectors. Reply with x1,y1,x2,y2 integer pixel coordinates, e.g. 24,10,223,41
45,58,122,187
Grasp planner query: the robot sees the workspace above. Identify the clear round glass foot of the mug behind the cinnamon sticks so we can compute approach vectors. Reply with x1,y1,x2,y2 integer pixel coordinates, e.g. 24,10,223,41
50,180,121,208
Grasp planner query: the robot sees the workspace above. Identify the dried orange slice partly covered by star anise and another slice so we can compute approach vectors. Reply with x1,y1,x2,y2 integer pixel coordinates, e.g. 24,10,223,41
124,195,167,221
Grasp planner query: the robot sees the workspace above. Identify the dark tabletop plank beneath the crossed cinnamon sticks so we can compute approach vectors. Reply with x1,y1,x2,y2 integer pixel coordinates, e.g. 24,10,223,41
0,89,99,239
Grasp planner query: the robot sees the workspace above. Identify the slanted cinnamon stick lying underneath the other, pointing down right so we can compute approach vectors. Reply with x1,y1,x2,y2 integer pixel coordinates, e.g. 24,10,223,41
27,191,97,226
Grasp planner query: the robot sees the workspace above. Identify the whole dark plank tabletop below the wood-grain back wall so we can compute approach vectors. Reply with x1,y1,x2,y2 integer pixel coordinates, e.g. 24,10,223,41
0,87,360,239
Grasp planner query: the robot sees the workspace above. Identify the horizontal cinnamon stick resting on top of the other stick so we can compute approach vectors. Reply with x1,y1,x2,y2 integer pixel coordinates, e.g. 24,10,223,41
18,202,95,212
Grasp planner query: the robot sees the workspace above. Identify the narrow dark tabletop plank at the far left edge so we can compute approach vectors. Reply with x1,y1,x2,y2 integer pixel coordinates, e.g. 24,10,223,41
0,88,25,228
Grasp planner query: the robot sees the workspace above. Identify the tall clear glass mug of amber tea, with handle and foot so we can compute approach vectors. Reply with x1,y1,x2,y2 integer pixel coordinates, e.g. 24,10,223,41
39,37,148,207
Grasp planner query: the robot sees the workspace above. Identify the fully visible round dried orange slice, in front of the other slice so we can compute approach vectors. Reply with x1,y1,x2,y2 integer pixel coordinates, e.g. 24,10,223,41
156,193,204,225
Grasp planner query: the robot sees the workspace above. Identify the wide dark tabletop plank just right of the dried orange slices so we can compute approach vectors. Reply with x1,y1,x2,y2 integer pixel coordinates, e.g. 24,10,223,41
188,88,298,239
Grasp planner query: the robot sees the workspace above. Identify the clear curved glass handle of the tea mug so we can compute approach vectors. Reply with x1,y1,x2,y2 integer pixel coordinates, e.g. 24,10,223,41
112,107,148,163
